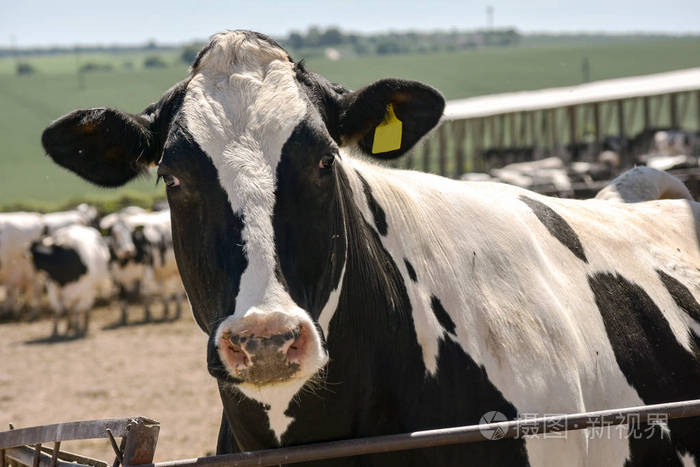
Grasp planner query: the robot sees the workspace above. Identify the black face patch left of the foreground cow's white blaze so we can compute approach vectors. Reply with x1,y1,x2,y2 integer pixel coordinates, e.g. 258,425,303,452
159,121,248,333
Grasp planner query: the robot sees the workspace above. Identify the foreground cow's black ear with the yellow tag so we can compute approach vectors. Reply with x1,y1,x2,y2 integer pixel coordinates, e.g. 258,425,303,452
338,79,445,159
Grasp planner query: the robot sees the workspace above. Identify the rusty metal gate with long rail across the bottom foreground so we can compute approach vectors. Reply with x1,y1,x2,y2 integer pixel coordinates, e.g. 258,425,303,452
0,399,700,467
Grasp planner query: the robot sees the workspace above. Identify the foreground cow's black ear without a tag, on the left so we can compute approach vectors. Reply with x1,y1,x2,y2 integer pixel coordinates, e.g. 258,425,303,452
41,108,160,187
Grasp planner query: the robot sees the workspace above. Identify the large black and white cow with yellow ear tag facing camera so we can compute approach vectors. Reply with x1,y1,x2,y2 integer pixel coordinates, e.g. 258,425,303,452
42,31,700,466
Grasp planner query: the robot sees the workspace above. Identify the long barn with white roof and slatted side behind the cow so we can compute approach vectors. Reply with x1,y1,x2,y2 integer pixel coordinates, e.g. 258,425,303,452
394,68,700,195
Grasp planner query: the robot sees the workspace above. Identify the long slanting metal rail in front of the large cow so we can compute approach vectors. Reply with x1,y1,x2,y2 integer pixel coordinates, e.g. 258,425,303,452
148,399,700,467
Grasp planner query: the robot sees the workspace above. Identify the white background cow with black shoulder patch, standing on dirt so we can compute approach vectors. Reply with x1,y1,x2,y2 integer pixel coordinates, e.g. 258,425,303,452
31,225,112,337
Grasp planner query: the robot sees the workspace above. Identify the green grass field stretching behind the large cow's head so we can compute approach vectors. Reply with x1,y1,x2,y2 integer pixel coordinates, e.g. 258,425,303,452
0,38,700,208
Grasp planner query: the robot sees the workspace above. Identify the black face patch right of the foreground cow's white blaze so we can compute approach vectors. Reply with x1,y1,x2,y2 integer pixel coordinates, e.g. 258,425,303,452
272,118,345,319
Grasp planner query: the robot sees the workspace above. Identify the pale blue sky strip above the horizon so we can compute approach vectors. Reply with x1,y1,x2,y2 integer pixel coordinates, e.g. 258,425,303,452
0,0,700,46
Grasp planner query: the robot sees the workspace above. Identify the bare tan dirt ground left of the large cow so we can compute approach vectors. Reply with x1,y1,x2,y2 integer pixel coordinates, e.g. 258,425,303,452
0,308,221,463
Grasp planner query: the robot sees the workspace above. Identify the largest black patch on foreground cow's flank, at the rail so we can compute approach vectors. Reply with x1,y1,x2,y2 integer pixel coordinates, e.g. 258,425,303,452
588,273,700,465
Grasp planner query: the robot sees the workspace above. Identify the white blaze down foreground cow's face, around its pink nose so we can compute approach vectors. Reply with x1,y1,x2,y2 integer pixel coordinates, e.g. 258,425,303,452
181,31,327,439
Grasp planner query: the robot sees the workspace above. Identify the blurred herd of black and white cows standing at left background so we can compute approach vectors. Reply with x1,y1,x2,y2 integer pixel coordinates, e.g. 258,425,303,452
0,204,184,337
